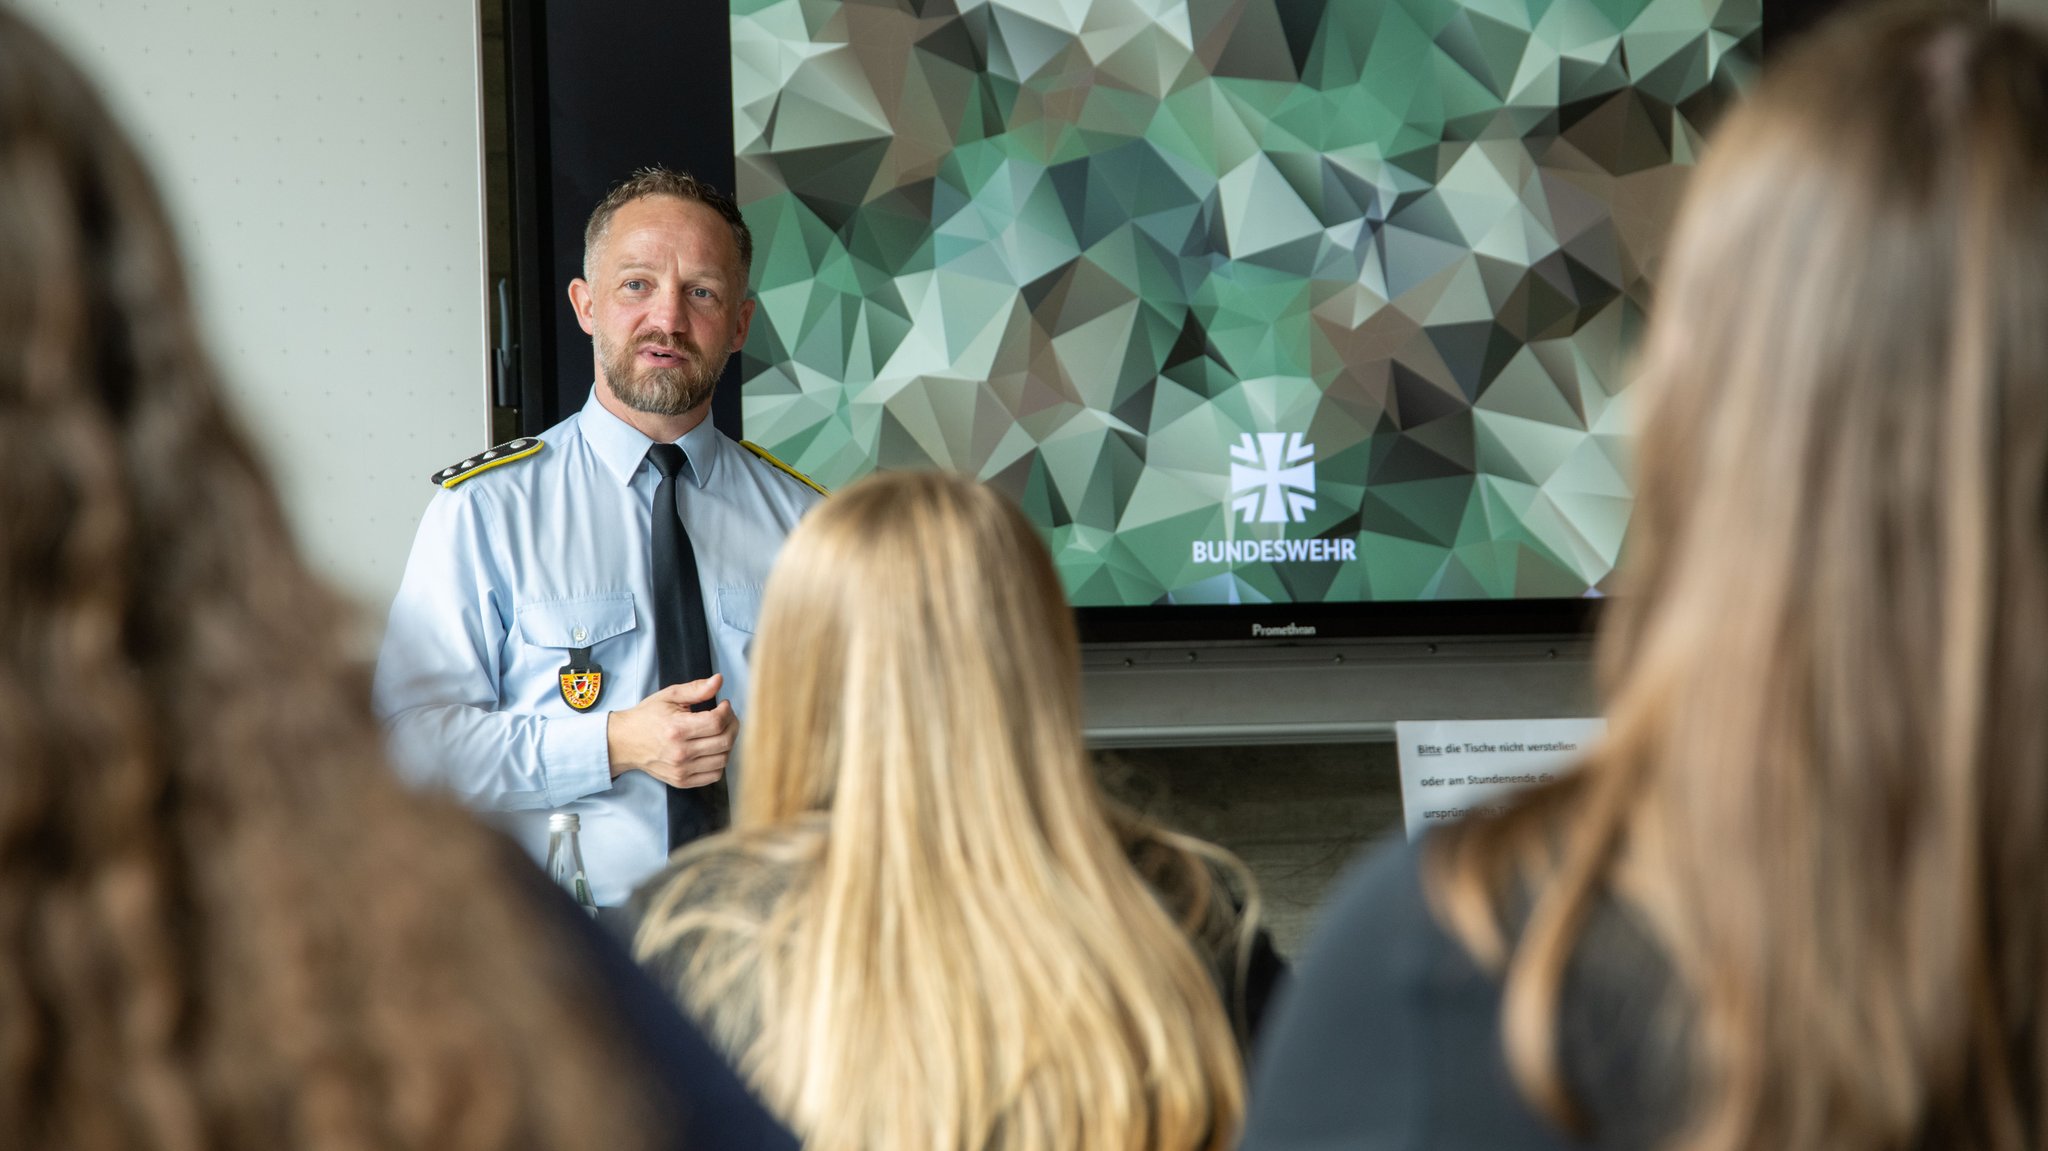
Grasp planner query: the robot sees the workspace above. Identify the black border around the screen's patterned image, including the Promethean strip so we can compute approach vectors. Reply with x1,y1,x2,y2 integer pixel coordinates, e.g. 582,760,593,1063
506,0,1855,645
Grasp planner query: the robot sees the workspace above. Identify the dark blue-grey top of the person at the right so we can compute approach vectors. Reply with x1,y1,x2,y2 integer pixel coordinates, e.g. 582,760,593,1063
1243,831,1683,1151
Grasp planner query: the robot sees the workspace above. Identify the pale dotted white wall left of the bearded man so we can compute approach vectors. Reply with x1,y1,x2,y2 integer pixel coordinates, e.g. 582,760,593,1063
12,0,489,631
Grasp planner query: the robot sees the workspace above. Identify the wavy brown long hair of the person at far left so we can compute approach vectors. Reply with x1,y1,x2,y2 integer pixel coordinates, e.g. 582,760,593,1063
0,10,651,1151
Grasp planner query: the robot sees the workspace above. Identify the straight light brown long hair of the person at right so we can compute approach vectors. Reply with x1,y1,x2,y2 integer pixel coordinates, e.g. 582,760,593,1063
1430,8,2048,1149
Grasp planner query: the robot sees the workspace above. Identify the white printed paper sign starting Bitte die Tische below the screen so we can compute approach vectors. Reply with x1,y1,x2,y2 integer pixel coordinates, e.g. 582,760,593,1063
1395,719,1608,840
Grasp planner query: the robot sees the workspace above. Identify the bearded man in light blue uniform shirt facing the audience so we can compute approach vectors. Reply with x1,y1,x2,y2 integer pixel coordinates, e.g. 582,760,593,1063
373,170,821,905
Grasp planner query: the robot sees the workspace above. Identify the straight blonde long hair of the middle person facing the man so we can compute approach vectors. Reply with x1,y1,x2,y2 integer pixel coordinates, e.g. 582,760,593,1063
637,473,1243,1151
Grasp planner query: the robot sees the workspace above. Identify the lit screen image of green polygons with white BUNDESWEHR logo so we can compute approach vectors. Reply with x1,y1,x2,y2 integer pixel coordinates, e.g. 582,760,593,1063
729,0,1761,637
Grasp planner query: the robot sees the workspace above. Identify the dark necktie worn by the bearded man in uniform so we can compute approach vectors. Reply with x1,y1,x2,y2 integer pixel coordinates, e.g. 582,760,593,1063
647,444,731,848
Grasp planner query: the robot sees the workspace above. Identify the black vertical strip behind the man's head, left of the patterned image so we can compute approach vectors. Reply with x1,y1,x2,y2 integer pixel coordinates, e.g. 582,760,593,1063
510,0,739,436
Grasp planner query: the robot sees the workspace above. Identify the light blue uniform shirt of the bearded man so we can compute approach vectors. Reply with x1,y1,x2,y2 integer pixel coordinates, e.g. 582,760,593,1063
373,391,819,905
